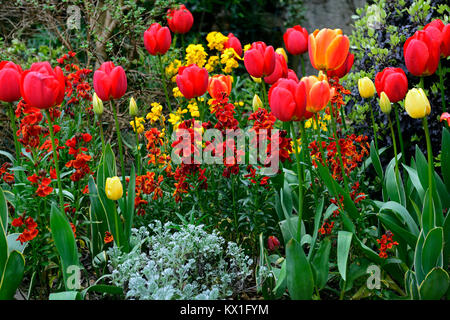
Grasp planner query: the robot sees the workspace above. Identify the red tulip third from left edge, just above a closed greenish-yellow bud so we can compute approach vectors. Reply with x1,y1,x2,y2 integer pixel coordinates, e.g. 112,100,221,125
94,61,127,101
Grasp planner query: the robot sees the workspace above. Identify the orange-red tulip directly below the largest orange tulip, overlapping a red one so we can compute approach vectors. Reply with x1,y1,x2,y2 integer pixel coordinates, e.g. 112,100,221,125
300,72,334,113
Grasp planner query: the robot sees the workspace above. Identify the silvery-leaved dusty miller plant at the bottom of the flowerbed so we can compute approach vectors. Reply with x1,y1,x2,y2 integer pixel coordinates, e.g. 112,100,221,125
108,221,253,300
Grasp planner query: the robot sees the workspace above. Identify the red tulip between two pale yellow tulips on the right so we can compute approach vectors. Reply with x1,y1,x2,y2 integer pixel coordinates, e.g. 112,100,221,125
375,68,408,102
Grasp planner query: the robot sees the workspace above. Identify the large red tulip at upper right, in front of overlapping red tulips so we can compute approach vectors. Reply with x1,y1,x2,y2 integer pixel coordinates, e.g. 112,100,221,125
403,27,442,77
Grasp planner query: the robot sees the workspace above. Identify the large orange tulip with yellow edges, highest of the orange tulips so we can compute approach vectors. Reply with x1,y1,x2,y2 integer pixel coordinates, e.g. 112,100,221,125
308,28,350,71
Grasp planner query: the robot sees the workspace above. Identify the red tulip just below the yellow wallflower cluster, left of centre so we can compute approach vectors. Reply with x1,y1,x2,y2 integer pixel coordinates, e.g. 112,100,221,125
177,64,209,100
